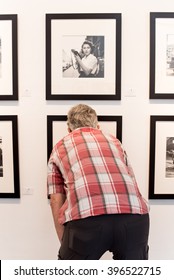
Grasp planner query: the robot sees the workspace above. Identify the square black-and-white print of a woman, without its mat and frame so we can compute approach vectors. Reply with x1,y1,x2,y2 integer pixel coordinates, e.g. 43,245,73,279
62,35,104,78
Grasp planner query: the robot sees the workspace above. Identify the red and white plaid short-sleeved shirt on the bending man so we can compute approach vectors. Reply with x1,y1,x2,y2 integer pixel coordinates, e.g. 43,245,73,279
47,127,148,224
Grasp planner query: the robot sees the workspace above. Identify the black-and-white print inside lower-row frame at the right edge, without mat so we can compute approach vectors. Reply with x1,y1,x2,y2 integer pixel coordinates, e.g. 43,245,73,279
166,137,174,178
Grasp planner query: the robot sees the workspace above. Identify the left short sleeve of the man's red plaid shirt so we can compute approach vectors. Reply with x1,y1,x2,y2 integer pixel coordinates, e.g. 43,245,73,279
47,155,65,195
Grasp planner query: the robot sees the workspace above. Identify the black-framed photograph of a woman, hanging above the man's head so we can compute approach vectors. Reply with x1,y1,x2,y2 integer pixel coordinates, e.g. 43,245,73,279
46,13,121,100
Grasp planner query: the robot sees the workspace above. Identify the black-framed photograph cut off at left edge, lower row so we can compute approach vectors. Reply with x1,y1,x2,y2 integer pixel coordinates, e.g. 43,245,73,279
0,115,20,198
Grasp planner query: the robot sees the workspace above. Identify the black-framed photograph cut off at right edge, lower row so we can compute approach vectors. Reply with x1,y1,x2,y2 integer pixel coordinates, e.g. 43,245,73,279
149,116,174,199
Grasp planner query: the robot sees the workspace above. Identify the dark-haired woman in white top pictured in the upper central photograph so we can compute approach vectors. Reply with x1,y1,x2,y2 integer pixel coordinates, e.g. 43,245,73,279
71,40,99,78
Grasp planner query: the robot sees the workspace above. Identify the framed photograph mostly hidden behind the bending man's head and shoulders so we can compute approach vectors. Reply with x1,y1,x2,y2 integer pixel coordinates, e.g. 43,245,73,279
47,116,122,159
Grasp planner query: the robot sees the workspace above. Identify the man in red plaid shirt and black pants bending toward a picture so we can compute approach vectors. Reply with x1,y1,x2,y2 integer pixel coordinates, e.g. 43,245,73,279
48,104,149,260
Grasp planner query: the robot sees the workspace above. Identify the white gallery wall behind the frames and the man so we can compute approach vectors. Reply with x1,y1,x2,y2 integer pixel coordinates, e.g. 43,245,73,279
0,0,174,259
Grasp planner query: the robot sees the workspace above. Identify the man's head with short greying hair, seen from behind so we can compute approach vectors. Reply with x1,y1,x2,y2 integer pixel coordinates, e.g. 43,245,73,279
67,104,99,131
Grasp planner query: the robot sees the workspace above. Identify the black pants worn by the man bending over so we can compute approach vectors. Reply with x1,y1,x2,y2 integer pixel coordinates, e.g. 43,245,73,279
58,214,149,260
